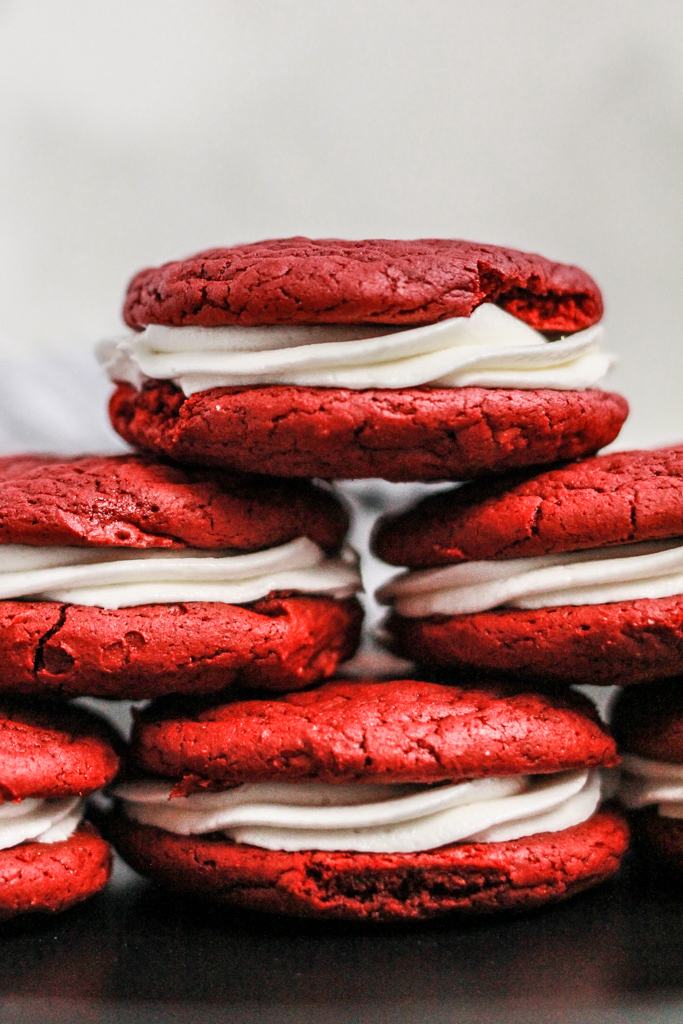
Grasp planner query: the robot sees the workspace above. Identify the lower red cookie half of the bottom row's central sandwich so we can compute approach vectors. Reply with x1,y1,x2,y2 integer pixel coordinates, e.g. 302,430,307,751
111,809,629,922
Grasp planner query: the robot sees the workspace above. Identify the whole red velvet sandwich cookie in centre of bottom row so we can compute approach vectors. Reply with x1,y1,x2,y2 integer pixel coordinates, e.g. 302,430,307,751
111,680,628,921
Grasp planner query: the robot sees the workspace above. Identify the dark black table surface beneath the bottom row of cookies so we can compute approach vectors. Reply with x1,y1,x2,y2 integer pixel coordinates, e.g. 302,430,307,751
0,861,683,1024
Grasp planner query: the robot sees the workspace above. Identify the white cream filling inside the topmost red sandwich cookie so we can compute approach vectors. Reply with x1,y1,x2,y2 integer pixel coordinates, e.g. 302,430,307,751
97,302,613,395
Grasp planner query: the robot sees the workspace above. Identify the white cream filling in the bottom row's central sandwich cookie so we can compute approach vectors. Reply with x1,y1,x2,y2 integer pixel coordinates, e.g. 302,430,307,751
112,771,601,853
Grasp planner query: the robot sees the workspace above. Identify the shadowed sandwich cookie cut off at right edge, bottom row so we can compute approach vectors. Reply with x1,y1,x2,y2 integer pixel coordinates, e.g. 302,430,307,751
611,678,683,873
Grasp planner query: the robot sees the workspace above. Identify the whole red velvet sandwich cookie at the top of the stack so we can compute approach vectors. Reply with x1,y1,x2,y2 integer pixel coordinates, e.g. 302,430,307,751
99,238,628,480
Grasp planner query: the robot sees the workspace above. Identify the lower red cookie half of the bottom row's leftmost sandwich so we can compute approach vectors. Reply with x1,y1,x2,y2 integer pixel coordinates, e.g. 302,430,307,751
0,822,112,921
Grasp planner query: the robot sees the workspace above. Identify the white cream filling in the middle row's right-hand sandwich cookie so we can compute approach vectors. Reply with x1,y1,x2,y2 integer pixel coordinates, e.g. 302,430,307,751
376,538,683,618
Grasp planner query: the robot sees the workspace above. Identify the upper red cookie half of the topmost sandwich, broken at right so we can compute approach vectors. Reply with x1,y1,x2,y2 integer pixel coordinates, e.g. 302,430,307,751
124,237,602,332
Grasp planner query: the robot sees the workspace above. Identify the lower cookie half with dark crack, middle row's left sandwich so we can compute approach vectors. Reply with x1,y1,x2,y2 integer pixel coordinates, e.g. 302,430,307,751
0,595,362,700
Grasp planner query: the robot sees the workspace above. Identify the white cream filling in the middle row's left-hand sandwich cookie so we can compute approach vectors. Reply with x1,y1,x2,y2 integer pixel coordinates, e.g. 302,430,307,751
0,537,362,608
